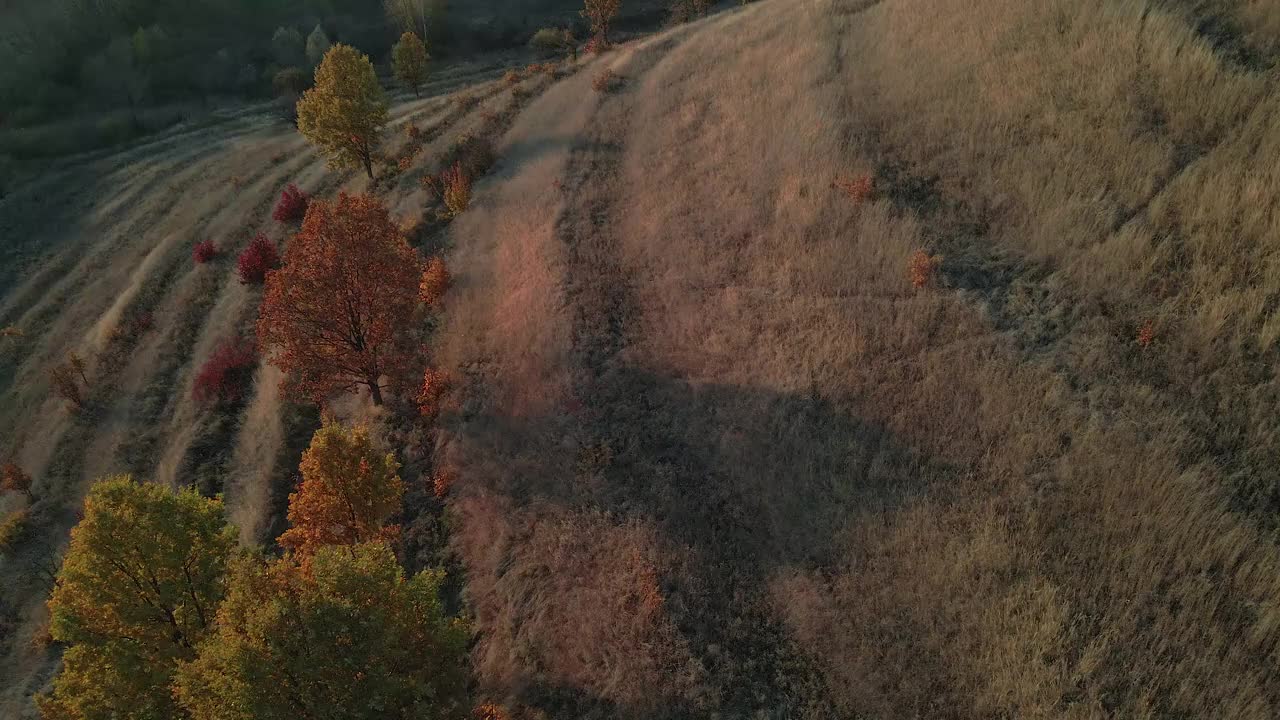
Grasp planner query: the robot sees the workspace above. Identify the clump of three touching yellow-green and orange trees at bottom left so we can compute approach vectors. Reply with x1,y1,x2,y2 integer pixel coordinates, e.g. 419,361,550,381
37,421,468,720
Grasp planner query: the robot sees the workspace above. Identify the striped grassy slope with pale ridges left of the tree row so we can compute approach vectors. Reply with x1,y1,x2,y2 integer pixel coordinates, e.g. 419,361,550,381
0,50,545,717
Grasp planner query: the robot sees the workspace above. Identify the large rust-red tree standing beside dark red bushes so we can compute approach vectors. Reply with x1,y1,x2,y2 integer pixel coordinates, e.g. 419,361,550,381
257,193,421,405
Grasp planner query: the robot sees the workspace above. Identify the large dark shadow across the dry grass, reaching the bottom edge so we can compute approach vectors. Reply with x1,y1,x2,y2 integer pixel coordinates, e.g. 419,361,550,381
452,366,960,717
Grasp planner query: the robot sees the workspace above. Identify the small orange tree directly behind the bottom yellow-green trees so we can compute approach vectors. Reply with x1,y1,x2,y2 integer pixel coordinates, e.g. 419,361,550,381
279,420,404,556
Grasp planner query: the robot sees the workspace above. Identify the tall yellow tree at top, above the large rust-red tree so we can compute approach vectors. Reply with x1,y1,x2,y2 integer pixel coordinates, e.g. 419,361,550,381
298,44,387,178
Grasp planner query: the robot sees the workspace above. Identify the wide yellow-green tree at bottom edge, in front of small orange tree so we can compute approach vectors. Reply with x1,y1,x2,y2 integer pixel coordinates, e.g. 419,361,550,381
174,543,467,720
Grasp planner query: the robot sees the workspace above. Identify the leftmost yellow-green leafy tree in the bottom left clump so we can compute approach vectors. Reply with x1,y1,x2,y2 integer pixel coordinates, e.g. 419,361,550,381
37,475,237,720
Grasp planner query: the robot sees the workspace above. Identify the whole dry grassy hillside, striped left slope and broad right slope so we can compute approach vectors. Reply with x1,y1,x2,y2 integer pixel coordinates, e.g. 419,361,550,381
0,0,1280,719
